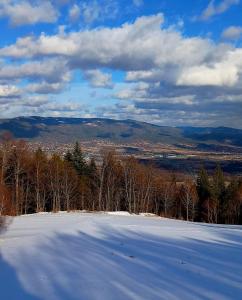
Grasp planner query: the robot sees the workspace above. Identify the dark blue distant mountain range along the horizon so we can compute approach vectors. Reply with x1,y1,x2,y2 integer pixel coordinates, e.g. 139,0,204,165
0,116,242,151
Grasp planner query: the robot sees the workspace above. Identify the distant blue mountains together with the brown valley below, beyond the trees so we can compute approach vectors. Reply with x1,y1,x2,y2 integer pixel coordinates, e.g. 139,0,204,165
0,117,242,175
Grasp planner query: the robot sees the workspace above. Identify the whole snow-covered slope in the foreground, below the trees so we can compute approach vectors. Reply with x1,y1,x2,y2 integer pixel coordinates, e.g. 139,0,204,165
0,213,242,300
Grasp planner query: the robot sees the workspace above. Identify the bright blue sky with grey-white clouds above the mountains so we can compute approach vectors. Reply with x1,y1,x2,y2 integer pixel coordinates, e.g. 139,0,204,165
0,0,242,128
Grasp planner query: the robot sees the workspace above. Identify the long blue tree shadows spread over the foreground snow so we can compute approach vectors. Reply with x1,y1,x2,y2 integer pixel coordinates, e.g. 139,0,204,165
3,226,242,300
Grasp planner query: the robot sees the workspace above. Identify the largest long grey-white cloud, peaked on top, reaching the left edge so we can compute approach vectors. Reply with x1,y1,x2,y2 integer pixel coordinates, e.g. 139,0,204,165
0,14,212,71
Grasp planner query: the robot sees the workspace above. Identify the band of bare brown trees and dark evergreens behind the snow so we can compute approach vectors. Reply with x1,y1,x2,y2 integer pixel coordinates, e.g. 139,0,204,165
0,140,242,224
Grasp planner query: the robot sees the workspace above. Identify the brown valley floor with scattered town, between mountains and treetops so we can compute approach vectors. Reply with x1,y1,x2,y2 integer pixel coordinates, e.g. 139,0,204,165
28,139,242,175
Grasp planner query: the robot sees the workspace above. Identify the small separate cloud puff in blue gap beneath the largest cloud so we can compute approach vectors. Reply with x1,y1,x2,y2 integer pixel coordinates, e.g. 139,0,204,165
83,70,114,88
